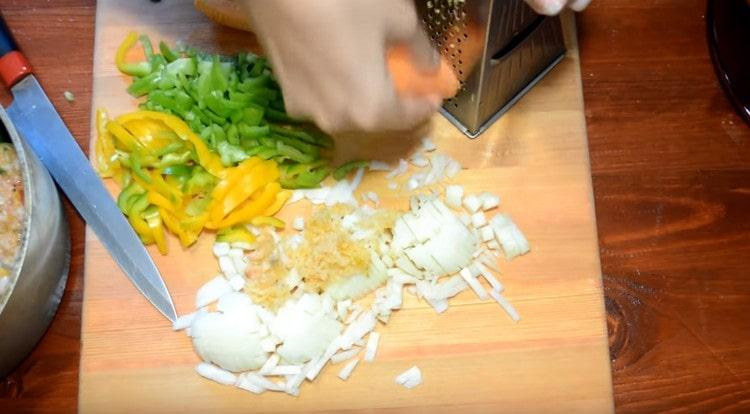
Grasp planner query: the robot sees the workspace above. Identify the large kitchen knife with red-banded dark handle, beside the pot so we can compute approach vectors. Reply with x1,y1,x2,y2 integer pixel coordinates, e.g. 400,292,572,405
0,16,176,322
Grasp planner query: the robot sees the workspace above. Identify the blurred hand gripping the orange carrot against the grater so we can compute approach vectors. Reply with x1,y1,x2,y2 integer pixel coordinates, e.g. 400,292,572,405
242,0,442,133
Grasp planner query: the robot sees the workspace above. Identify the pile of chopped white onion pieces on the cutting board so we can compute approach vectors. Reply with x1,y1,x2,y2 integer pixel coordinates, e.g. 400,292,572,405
182,138,529,396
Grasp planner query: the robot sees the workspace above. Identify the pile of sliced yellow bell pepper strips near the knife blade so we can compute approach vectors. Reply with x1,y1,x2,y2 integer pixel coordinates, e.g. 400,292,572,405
95,106,292,254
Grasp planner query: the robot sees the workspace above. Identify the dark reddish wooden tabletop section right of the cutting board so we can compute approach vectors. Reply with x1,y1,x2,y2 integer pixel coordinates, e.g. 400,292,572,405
580,0,750,413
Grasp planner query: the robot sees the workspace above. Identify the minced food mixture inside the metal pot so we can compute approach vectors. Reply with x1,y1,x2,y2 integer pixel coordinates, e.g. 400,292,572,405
0,142,24,298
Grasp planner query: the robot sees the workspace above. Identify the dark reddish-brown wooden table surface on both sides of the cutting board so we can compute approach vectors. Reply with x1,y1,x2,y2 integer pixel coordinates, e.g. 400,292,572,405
0,0,750,413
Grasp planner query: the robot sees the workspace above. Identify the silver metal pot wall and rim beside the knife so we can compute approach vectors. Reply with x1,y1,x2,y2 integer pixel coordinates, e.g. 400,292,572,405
0,103,70,377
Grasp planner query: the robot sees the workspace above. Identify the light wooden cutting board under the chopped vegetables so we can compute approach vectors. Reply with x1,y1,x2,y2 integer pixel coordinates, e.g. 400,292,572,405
79,0,613,413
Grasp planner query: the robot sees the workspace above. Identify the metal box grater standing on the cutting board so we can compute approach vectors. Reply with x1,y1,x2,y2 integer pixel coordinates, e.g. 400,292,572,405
416,0,565,138
